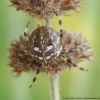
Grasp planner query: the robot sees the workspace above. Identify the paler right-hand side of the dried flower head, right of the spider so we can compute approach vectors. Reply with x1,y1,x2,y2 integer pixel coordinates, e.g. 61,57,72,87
63,33,92,62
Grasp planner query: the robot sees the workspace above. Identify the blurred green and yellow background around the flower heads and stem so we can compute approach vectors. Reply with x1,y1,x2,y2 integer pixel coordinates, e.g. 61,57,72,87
0,0,100,100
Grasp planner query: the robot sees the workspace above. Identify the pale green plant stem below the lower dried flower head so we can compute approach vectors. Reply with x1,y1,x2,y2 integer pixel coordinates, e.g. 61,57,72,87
49,75,60,100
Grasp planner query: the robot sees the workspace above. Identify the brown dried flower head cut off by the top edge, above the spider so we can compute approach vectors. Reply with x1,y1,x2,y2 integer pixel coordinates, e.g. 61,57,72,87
10,0,80,18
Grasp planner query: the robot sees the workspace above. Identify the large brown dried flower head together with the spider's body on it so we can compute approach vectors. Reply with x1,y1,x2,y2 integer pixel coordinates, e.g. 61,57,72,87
9,26,92,74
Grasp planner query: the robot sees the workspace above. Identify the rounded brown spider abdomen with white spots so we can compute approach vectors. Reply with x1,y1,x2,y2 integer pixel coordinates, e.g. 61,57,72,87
29,26,62,62
